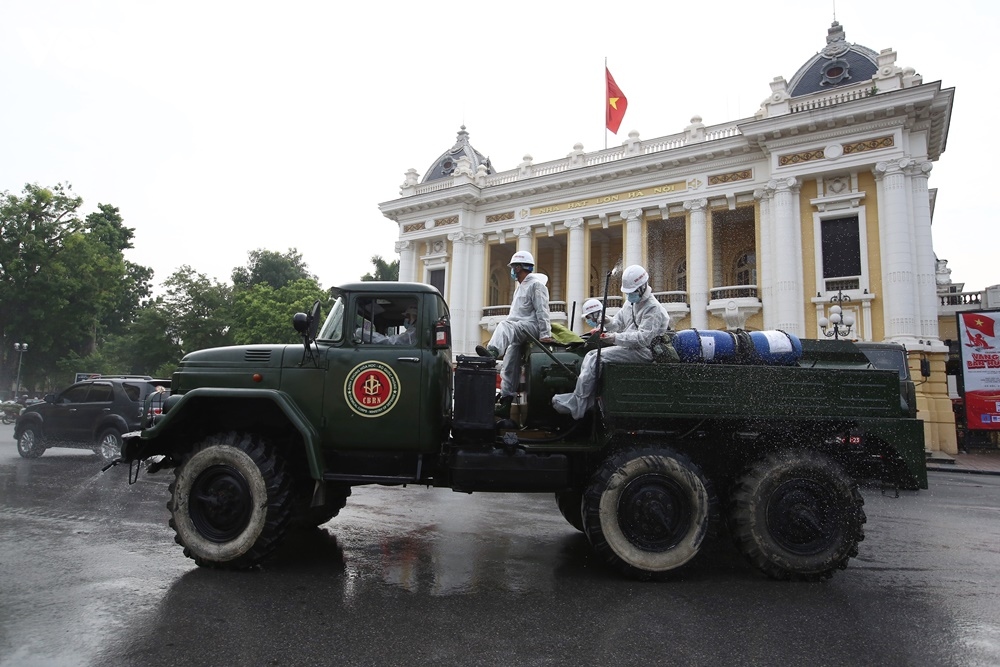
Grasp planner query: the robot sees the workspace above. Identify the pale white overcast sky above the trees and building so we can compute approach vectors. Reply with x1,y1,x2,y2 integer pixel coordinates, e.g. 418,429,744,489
0,0,1000,290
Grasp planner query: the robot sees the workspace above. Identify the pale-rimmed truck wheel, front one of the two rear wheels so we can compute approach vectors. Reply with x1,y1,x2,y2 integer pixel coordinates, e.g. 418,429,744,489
583,447,712,579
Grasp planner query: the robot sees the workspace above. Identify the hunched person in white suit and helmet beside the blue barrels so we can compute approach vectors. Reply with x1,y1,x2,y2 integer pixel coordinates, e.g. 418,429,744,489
552,264,670,419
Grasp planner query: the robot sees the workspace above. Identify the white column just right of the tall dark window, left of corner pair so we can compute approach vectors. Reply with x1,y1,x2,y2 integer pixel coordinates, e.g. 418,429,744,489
875,158,919,344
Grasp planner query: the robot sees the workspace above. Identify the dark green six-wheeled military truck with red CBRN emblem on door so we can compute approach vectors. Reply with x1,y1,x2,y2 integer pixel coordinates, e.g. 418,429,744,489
121,282,927,580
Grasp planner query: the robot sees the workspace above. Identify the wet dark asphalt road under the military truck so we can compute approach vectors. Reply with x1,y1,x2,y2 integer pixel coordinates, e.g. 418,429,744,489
0,426,1000,667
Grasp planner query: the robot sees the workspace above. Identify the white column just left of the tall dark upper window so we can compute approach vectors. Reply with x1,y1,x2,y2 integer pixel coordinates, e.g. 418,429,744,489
767,177,805,337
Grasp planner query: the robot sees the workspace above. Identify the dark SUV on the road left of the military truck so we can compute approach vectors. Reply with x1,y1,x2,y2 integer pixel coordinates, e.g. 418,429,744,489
14,376,170,463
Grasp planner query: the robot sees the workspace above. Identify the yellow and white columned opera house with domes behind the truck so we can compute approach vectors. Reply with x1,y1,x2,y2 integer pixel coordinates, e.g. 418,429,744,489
380,22,957,453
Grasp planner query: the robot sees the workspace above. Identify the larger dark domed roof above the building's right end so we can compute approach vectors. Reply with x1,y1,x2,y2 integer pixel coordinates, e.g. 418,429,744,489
788,21,878,97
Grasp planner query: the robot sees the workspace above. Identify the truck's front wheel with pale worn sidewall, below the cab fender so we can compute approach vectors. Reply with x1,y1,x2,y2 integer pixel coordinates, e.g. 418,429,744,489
167,433,293,569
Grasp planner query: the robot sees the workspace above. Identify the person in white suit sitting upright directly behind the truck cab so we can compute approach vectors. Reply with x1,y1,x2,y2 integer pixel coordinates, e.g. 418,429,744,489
476,250,553,406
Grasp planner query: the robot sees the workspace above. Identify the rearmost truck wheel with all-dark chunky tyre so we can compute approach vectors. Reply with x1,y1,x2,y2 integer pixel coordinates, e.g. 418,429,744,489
729,451,866,581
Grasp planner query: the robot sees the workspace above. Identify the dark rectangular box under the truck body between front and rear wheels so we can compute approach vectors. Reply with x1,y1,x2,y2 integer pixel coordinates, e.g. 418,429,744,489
451,449,569,492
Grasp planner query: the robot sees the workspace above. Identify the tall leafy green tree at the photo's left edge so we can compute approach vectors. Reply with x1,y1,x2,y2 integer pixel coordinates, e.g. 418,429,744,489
0,184,152,389
